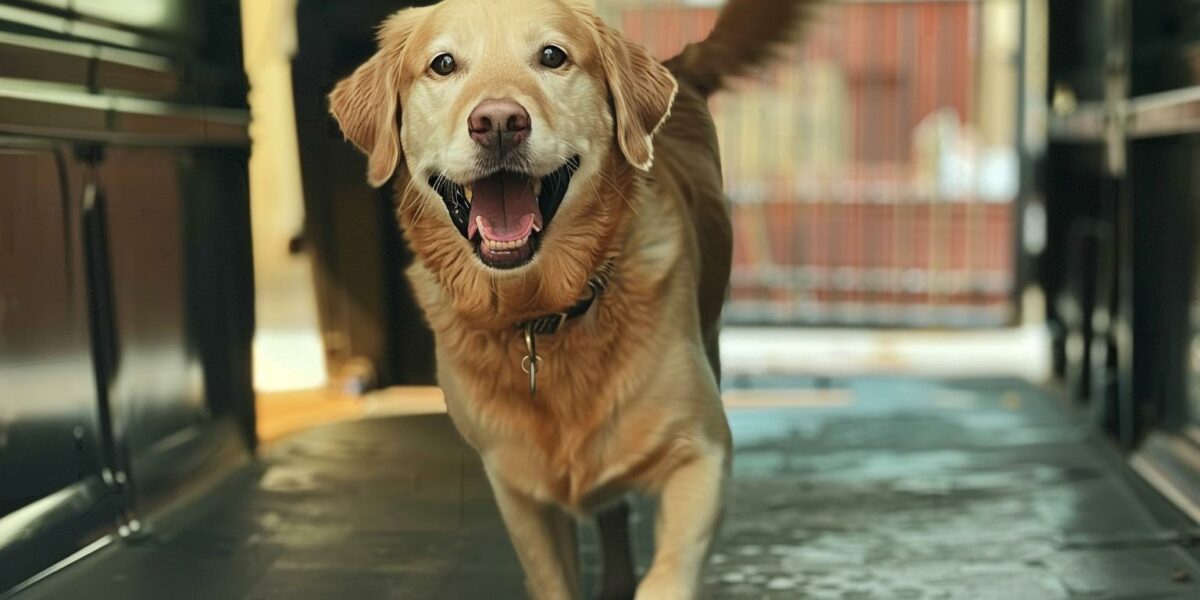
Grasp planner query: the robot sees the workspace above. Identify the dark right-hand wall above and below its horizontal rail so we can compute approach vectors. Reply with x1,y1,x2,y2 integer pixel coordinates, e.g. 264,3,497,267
1039,0,1200,449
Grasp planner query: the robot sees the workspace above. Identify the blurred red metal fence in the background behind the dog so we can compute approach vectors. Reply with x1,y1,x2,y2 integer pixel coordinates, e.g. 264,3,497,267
609,0,1018,326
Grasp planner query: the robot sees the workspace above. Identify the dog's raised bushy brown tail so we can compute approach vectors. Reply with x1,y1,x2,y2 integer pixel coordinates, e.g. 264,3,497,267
666,0,827,95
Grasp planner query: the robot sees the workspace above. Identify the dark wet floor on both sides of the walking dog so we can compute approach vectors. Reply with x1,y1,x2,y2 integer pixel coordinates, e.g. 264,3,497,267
18,379,1200,600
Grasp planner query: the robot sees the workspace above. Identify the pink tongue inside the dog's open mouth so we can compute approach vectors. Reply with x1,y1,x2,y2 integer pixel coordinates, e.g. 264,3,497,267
467,173,541,241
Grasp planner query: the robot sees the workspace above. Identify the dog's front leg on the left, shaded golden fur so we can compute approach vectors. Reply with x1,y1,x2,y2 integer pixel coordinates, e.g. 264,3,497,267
488,473,580,600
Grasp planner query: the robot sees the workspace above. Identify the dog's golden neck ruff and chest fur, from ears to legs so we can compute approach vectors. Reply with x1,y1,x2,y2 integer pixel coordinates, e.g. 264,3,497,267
409,183,712,510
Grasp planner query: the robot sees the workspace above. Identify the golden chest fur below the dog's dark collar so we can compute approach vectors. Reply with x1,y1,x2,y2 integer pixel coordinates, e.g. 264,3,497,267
448,314,700,511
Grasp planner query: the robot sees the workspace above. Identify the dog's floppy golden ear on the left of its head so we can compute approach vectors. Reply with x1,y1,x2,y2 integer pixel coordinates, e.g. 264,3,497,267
329,7,432,187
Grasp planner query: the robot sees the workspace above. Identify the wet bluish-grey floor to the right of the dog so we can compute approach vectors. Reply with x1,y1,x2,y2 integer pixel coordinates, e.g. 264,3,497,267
709,380,1200,600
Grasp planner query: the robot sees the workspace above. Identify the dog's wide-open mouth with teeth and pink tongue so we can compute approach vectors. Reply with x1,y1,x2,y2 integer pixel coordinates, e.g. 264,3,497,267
430,156,580,269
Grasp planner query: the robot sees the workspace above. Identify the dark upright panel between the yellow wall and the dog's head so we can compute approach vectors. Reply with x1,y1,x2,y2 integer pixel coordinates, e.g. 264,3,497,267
293,0,434,385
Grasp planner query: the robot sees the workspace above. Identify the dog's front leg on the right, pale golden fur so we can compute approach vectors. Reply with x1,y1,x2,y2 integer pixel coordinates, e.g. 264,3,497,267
635,448,728,600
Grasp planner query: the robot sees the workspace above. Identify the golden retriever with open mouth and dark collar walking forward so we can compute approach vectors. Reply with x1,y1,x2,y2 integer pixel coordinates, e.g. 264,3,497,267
330,0,812,600
